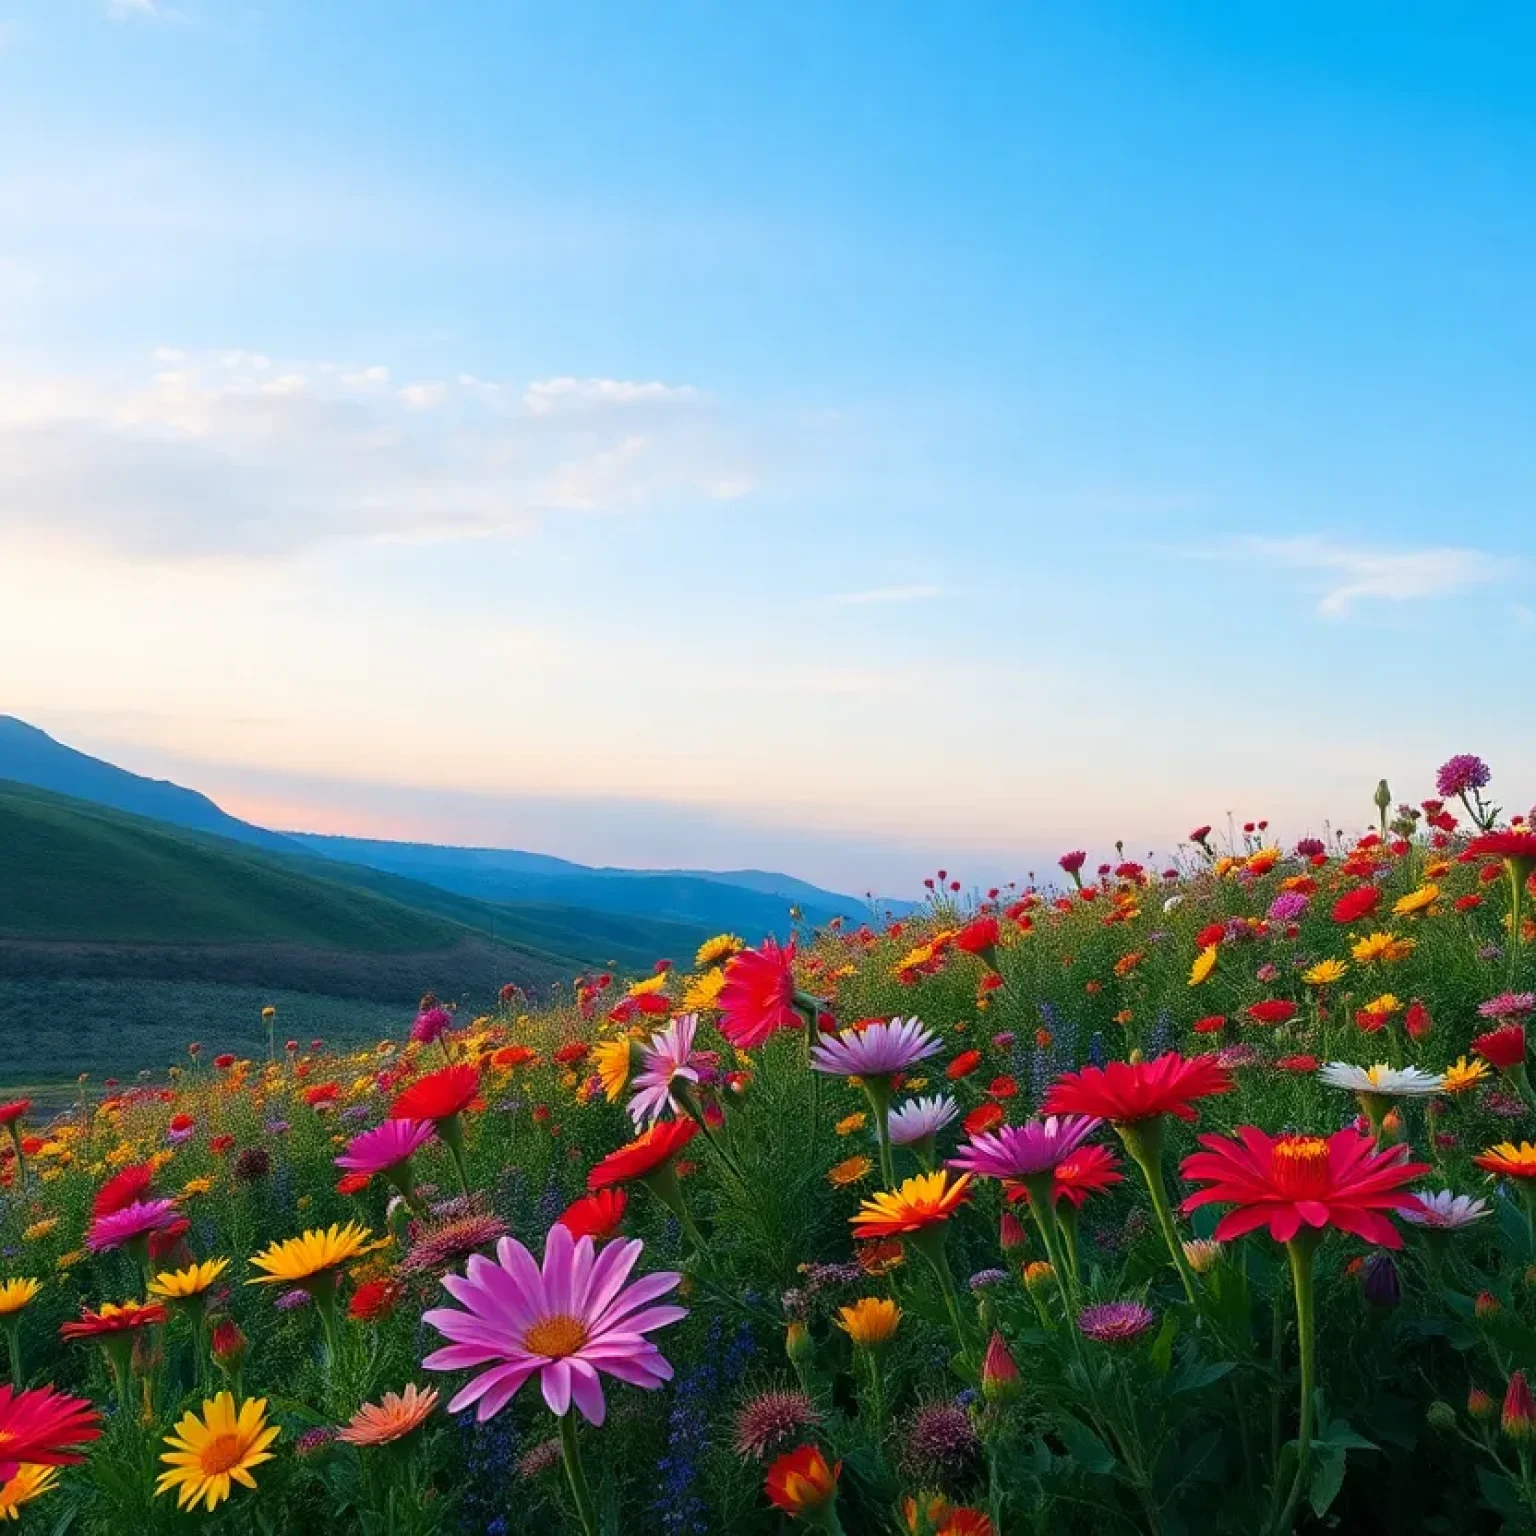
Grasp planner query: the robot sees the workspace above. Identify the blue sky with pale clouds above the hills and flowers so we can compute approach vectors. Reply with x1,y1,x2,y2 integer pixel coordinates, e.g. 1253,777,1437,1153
0,0,1536,895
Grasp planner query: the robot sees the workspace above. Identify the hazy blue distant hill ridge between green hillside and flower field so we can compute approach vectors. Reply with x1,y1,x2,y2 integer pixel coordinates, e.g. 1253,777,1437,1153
284,833,868,943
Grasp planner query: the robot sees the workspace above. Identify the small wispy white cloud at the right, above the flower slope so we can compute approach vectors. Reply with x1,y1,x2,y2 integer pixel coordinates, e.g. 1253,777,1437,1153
1226,535,1511,619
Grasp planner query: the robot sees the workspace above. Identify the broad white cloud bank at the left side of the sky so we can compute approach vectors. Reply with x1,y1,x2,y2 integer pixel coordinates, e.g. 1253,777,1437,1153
0,347,756,559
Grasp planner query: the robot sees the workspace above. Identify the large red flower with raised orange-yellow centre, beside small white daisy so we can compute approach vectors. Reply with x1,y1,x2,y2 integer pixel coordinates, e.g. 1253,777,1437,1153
1183,1126,1430,1249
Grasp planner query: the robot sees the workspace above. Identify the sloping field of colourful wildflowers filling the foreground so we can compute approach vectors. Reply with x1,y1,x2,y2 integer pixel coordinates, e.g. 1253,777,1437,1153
0,756,1536,1536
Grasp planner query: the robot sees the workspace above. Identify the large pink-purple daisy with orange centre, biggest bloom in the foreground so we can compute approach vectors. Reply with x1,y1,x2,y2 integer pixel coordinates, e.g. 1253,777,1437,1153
422,1224,688,1424
